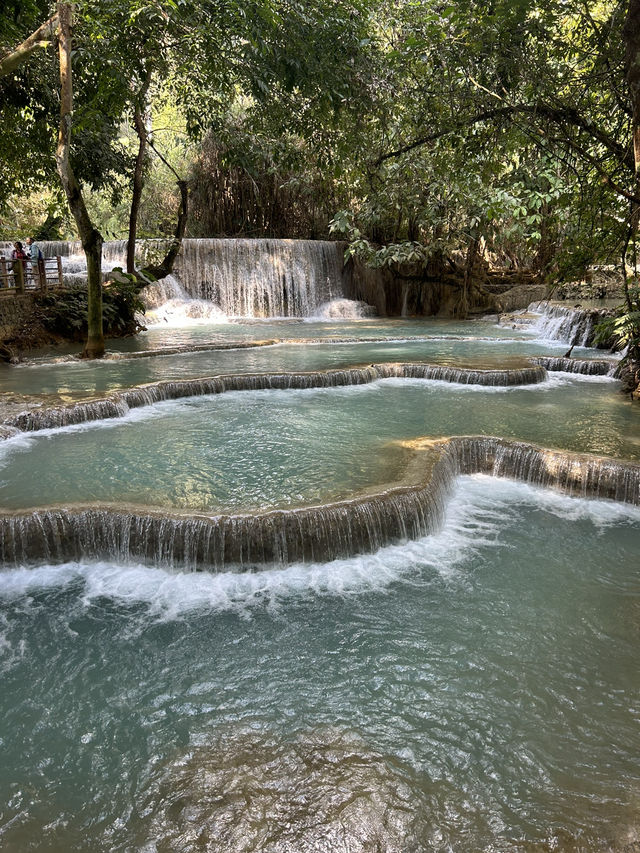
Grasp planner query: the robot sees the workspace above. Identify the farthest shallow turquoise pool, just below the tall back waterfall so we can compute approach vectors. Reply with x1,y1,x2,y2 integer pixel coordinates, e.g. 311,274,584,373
0,321,603,400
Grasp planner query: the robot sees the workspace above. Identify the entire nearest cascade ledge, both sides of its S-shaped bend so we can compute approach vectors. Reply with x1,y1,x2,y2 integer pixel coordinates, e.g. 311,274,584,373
0,436,640,571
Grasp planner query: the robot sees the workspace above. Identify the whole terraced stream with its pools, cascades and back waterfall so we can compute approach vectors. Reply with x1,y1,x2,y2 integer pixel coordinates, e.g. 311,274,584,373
0,255,640,853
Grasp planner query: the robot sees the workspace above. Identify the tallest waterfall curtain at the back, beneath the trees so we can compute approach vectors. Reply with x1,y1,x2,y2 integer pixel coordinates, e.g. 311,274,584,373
176,239,343,317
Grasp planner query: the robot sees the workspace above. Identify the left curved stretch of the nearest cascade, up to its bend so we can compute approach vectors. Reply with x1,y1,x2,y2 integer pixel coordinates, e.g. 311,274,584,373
0,476,445,571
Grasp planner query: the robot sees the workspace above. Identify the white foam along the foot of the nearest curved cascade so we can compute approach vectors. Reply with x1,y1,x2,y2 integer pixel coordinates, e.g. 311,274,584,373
0,475,640,620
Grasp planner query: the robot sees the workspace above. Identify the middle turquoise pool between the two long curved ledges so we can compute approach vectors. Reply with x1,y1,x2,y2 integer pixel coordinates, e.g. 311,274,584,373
0,374,640,511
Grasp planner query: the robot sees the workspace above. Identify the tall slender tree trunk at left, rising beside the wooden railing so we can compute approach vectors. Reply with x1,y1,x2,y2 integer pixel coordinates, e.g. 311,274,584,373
56,3,104,358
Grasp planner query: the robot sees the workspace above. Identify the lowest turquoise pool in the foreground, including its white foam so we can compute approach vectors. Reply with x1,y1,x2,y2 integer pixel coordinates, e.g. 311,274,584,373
0,477,640,853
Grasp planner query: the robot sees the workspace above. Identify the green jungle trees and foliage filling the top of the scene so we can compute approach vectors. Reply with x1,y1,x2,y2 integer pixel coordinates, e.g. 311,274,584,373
0,0,640,362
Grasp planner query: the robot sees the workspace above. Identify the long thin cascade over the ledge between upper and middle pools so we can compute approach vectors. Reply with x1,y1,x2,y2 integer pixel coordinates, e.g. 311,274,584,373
4,364,547,432
